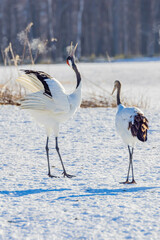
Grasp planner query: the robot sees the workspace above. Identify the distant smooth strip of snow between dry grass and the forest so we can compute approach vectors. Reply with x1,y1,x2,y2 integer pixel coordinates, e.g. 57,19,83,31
0,61,160,110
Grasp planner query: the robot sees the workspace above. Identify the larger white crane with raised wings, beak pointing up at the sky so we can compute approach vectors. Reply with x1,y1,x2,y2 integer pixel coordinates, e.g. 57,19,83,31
17,45,81,178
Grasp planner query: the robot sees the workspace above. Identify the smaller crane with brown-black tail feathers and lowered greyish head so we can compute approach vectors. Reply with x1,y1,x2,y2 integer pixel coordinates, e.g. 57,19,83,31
112,80,148,184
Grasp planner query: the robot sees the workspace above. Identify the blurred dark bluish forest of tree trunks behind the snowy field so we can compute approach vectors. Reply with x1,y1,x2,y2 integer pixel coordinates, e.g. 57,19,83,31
0,0,160,62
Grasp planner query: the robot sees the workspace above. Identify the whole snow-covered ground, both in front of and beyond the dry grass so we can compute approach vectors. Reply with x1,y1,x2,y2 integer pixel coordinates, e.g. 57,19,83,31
0,62,160,240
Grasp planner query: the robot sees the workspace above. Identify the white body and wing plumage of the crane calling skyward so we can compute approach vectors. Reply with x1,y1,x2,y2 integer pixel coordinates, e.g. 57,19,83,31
18,74,81,136
